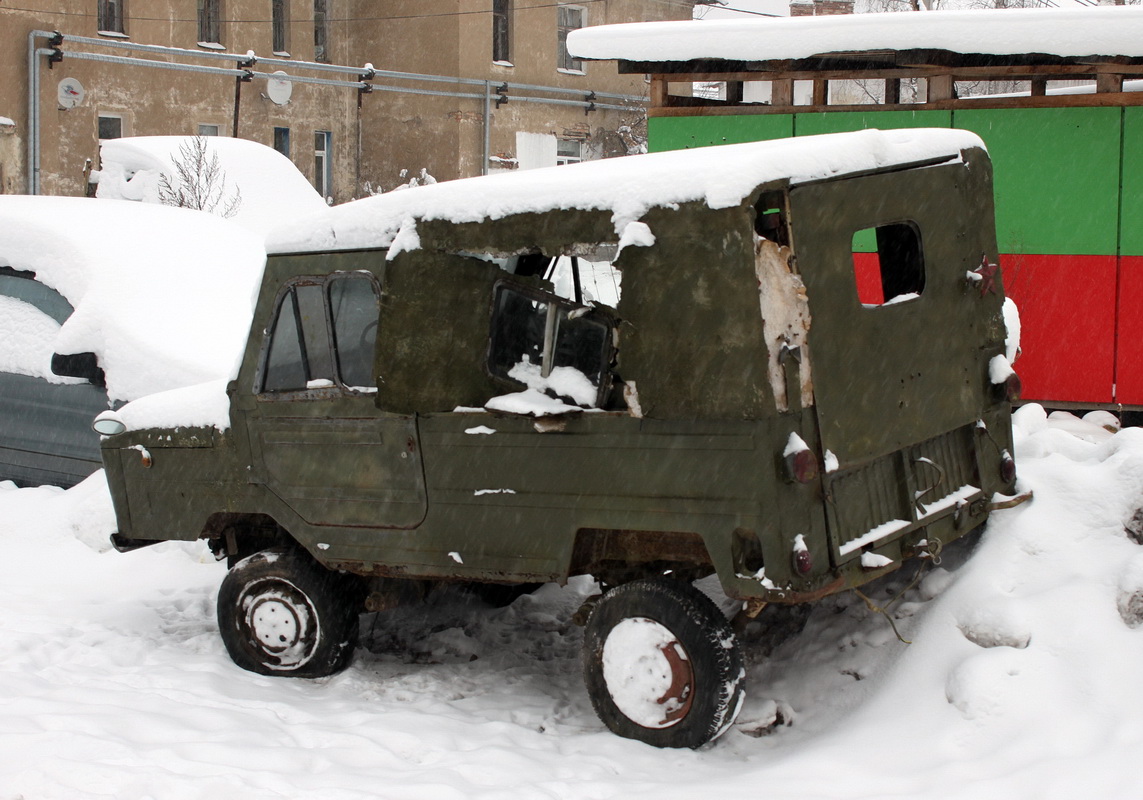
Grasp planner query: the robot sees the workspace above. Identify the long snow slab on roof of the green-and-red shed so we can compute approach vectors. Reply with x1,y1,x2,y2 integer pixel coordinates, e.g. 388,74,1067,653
568,6,1143,62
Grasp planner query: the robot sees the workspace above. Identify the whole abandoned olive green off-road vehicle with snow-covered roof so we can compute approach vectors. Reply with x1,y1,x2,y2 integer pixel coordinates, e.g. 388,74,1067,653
96,130,1018,747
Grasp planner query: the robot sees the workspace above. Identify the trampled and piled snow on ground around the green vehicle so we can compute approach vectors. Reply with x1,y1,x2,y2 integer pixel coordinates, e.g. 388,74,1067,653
0,406,1143,800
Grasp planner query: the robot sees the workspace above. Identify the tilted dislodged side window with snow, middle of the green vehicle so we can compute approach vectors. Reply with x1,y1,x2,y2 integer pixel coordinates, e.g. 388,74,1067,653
488,283,610,407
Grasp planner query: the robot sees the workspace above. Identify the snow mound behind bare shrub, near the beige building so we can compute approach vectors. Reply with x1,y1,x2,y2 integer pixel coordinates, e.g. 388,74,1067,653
96,136,326,235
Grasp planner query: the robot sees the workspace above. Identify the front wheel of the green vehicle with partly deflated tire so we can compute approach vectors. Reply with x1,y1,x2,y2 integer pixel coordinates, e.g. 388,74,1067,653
218,547,360,678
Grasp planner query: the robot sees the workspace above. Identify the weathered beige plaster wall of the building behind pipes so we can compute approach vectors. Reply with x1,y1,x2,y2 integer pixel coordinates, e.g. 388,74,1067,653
0,0,693,202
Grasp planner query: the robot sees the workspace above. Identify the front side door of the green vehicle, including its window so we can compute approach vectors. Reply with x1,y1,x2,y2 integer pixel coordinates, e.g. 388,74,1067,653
247,271,426,528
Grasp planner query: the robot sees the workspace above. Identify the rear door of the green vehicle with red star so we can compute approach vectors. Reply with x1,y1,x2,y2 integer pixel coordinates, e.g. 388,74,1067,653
790,163,1000,562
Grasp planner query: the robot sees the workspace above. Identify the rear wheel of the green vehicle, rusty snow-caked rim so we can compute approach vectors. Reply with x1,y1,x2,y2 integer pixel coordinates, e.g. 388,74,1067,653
583,578,745,747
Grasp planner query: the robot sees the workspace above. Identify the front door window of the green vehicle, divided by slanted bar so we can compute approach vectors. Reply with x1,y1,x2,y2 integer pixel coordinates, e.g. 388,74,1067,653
262,274,378,392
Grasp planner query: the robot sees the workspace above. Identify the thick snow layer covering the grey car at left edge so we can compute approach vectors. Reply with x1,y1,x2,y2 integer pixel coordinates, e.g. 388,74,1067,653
0,195,265,400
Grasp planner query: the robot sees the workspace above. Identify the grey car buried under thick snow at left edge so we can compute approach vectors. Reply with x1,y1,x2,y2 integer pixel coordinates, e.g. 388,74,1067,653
0,195,265,486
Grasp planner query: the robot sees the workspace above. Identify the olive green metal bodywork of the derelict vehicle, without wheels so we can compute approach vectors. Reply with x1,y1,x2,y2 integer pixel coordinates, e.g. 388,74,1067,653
96,145,1013,602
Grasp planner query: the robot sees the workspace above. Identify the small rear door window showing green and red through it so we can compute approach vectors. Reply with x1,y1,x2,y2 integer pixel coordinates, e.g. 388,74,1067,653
852,222,925,307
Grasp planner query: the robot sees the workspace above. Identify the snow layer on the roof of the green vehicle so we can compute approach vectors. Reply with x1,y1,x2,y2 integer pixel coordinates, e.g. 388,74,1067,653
267,128,984,256
